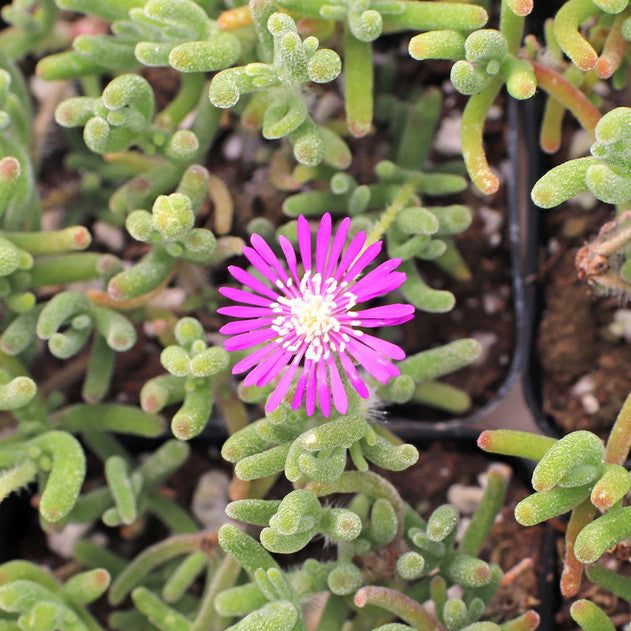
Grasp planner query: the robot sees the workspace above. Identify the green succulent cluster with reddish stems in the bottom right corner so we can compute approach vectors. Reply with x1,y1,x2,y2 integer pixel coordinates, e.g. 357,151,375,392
478,420,631,631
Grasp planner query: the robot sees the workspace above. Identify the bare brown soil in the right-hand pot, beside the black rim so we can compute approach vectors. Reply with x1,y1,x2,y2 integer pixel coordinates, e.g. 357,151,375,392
537,204,631,438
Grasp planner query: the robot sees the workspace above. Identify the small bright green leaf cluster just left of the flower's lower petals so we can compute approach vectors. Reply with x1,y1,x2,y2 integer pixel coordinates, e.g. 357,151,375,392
140,317,228,440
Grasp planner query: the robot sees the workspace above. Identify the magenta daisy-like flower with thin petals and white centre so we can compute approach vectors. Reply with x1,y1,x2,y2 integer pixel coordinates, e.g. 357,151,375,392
218,213,414,417
